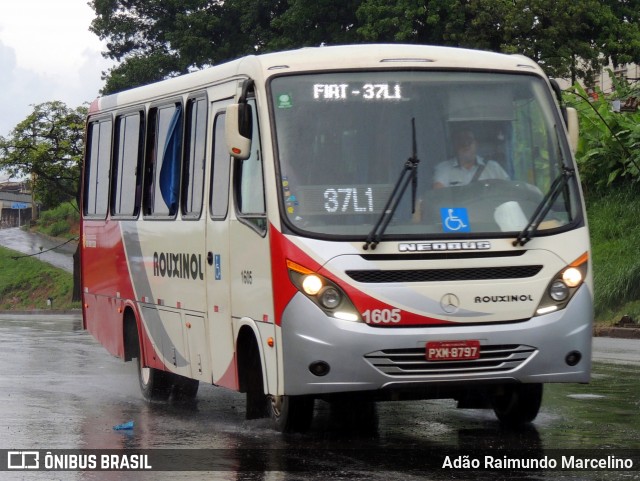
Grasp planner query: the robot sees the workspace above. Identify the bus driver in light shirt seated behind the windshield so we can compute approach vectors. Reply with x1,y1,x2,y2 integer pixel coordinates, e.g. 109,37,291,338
433,130,509,189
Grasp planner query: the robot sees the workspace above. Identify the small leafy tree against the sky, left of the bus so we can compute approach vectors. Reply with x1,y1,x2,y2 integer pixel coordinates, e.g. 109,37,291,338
0,101,87,209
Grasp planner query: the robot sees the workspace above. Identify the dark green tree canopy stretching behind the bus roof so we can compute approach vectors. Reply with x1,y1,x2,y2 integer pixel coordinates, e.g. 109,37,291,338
91,0,640,93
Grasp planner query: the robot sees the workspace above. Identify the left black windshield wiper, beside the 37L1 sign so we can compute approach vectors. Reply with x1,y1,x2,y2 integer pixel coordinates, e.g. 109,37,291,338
362,117,420,250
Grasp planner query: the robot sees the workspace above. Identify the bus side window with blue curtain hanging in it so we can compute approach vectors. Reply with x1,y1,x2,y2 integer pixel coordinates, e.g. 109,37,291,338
143,103,182,217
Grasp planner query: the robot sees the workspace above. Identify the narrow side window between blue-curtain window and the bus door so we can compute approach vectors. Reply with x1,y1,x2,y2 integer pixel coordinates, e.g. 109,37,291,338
182,97,207,218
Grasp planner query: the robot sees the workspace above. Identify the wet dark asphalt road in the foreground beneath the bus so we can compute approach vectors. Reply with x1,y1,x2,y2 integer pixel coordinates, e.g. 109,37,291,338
0,314,640,481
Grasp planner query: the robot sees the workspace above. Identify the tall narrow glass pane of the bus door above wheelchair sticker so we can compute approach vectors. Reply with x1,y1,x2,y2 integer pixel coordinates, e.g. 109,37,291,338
209,113,231,219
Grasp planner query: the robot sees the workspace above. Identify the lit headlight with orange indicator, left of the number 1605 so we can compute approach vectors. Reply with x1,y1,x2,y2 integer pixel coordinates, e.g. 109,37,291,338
287,260,362,322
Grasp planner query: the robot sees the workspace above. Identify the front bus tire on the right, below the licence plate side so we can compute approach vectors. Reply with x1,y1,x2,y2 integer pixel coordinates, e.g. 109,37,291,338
491,384,542,427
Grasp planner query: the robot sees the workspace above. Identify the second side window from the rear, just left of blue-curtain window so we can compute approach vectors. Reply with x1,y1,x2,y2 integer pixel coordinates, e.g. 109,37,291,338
111,112,144,217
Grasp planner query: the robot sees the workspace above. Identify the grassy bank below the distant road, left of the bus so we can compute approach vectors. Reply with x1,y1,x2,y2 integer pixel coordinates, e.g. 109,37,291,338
0,247,80,311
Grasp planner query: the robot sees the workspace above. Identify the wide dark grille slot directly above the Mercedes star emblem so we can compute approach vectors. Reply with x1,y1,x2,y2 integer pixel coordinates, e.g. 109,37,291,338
346,265,542,283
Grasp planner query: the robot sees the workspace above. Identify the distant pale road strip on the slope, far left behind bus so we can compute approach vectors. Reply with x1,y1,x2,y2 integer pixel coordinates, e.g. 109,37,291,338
0,227,76,272
